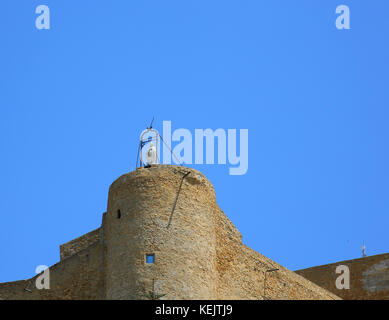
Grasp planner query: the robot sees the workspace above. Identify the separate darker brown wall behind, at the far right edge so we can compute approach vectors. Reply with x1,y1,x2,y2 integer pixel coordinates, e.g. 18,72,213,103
296,253,389,300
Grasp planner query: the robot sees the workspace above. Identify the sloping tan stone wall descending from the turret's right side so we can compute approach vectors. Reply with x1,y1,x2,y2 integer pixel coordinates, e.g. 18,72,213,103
216,208,339,300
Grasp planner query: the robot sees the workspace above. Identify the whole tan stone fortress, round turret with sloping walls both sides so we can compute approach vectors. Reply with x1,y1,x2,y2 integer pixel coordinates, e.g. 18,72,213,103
0,165,338,300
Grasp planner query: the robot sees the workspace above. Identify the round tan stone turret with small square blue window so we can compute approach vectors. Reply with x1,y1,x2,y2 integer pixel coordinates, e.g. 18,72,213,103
103,165,217,299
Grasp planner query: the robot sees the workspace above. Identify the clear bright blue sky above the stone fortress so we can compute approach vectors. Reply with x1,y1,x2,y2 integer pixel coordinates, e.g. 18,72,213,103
0,0,389,282
